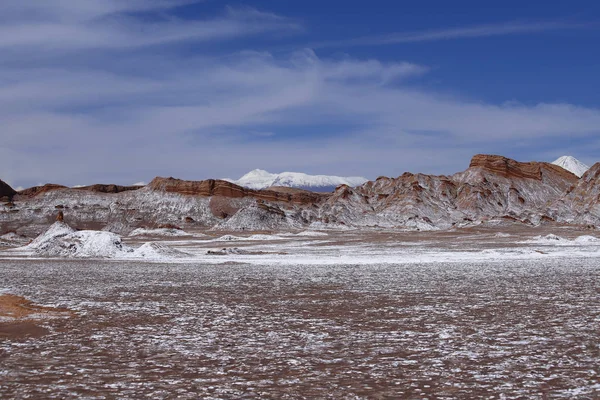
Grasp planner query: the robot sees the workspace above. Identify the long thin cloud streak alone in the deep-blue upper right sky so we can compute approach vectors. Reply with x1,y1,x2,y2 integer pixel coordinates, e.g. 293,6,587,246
310,21,589,48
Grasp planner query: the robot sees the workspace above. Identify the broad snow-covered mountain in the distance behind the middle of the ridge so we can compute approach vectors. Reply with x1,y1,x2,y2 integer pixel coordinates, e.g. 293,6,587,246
225,169,367,192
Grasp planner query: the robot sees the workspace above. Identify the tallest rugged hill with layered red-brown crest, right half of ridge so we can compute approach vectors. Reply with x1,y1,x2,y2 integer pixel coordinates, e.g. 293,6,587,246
322,155,578,229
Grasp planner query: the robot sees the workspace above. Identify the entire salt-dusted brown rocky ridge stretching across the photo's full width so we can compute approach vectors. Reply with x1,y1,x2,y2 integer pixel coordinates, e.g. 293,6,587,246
0,155,600,234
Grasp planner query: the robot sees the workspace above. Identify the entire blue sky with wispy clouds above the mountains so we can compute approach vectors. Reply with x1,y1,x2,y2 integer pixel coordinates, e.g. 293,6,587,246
0,0,600,186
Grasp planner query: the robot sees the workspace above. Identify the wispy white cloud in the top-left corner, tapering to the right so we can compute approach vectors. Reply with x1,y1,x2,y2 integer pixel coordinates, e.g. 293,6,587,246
0,0,300,51
